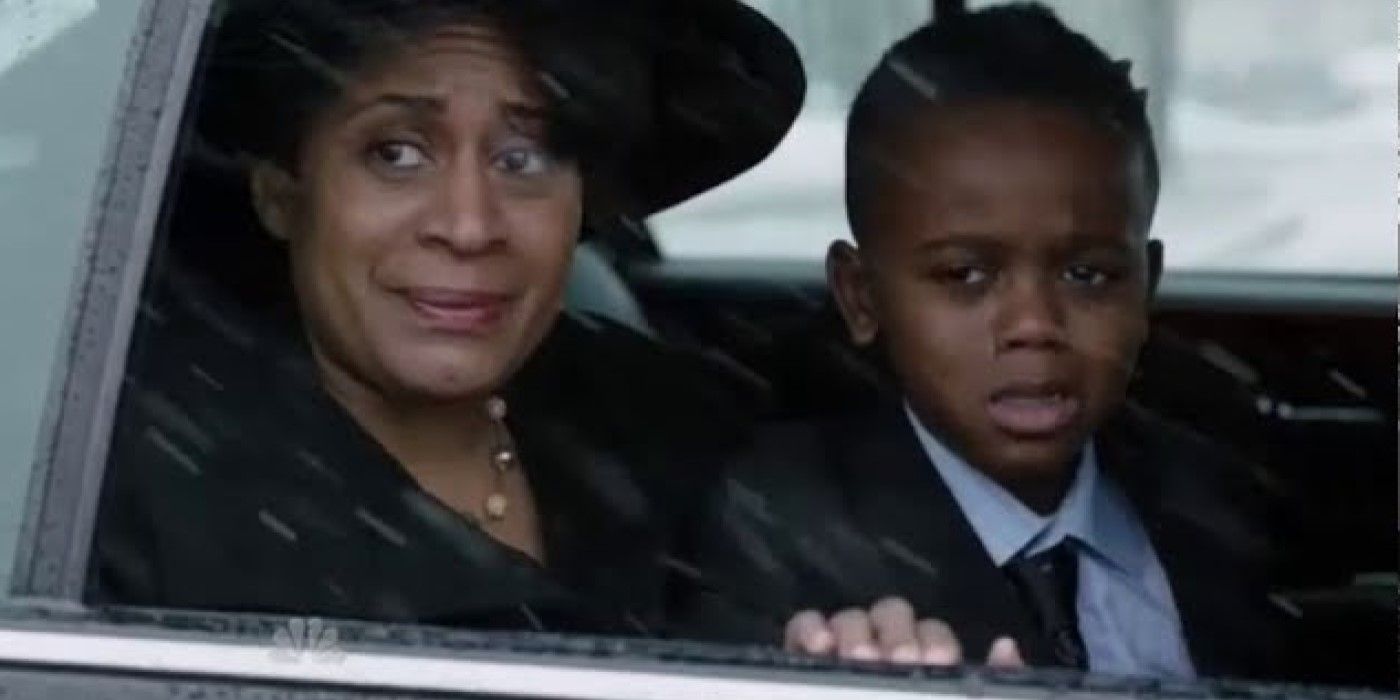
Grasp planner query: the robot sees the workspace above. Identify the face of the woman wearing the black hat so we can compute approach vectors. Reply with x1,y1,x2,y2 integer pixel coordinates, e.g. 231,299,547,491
253,28,582,402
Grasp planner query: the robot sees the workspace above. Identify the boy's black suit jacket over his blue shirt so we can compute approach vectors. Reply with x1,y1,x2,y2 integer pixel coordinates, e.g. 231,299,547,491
689,405,1296,678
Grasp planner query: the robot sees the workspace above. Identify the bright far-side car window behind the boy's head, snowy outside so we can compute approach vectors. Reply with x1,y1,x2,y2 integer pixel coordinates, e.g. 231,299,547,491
657,0,1396,276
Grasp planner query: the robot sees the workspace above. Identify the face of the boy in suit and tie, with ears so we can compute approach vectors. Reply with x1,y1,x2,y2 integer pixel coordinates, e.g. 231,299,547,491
827,101,1161,504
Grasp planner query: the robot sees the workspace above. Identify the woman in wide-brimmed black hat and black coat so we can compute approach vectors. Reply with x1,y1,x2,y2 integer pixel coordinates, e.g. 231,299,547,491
91,0,804,633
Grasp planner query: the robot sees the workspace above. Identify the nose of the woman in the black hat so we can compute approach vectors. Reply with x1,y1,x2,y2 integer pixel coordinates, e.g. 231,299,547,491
421,158,504,256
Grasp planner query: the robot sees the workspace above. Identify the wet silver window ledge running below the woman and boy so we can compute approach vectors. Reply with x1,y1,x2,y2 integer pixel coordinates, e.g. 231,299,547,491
0,606,1344,700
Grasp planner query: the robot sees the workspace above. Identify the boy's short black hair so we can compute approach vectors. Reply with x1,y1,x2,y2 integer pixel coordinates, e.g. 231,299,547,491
846,3,1159,239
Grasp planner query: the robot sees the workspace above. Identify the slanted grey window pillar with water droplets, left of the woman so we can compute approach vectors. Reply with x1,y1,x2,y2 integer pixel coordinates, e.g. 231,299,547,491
10,0,213,605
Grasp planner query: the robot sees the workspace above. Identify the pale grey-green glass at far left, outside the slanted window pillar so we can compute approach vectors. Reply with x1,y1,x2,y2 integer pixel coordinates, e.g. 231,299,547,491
0,0,143,589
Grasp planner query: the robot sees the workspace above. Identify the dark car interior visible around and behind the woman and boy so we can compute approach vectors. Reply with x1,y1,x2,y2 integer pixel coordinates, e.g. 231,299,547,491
137,132,1397,686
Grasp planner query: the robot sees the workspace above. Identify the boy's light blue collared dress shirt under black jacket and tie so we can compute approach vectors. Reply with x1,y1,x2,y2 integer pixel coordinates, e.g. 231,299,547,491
906,406,1196,678
